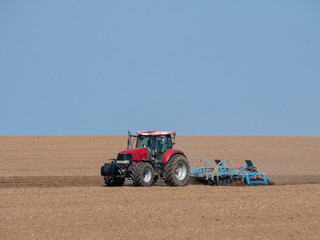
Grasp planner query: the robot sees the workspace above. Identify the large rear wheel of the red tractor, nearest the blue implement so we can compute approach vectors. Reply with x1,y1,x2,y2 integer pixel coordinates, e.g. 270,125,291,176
164,154,190,186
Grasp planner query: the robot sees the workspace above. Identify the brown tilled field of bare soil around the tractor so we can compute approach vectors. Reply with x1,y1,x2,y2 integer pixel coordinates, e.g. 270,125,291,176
0,136,320,240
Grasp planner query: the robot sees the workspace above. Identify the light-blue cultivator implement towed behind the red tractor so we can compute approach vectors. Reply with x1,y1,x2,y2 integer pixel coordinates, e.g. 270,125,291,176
190,158,272,185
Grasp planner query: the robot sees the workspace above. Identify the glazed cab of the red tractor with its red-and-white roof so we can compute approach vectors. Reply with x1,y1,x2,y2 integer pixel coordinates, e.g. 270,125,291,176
136,131,175,161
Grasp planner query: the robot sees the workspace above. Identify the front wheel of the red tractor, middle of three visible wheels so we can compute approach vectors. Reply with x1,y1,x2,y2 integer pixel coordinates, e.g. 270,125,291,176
132,162,154,187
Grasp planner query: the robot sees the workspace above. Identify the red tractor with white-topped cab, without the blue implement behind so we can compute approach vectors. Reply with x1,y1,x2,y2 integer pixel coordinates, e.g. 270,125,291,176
101,131,190,186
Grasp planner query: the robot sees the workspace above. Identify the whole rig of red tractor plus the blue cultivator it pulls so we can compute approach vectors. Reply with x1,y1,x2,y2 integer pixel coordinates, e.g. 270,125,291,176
101,131,272,186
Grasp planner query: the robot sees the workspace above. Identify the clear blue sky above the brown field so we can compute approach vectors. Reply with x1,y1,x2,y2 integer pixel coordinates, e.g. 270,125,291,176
0,0,320,136
